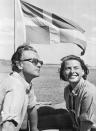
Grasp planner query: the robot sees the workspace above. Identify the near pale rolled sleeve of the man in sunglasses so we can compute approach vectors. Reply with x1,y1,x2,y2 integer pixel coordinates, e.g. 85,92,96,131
2,85,25,123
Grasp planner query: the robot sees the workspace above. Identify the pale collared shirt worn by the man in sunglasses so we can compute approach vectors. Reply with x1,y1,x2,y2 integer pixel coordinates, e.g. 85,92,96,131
0,72,36,128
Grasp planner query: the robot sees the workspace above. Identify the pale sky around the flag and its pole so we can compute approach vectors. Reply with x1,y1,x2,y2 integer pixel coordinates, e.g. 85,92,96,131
0,0,96,66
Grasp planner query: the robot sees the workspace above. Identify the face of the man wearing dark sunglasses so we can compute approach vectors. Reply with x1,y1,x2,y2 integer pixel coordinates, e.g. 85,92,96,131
21,50,41,78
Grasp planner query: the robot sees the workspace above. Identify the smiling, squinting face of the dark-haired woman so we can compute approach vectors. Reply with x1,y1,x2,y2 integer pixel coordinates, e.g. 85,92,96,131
64,60,84,83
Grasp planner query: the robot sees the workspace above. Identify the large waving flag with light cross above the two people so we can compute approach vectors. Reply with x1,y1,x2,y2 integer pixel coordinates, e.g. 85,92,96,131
20,0,86,55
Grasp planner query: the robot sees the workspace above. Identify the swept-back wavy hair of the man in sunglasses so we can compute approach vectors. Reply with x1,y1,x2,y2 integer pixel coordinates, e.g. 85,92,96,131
11,43,37,72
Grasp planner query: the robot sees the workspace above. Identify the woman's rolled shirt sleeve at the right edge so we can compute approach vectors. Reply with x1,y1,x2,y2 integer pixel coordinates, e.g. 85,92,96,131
80,92,96,123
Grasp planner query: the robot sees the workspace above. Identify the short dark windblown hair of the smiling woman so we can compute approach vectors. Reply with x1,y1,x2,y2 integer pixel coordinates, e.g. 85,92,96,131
60,55,89,81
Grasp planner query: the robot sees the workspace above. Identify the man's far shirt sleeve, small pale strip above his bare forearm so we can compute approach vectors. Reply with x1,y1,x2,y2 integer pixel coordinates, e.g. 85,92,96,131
28,87,37,108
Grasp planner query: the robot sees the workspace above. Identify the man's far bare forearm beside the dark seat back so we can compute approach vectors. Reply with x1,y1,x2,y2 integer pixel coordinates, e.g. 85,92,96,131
28,107,38,131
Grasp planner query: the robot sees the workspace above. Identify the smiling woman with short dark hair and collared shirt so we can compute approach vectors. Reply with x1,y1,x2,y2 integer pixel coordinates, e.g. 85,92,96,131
60,55,96,131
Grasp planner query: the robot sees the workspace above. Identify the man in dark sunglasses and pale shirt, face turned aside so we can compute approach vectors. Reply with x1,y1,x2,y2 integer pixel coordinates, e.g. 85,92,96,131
0,43,43,131
